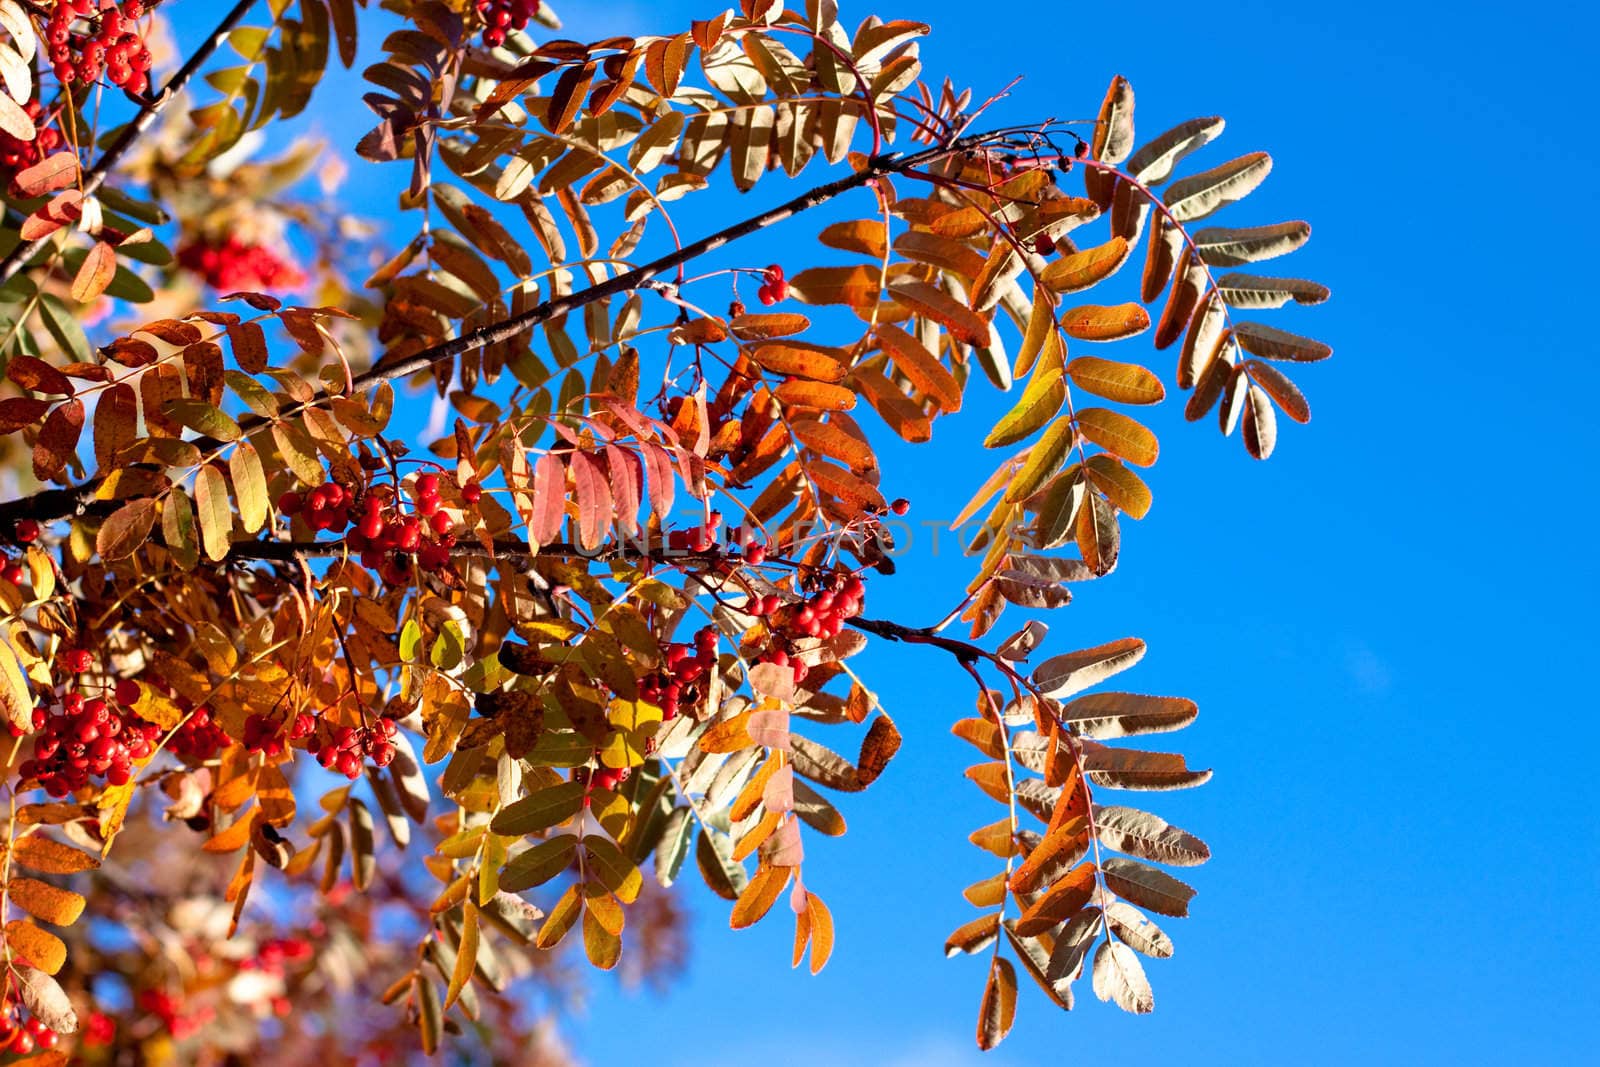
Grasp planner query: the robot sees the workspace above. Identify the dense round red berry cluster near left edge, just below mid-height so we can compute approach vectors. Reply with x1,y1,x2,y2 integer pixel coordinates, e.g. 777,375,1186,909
21,684,162,797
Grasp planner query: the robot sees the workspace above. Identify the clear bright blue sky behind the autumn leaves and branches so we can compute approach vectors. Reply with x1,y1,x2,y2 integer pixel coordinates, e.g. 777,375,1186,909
190,0,1600,1067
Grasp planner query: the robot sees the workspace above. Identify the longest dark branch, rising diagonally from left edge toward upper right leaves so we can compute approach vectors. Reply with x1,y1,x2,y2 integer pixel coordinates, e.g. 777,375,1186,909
0,127,1018,533
